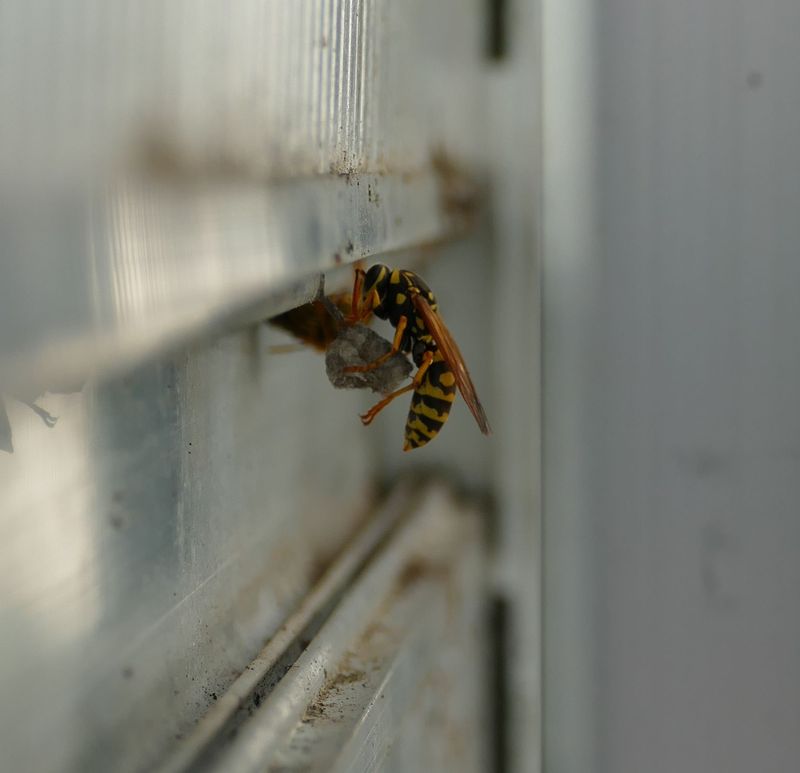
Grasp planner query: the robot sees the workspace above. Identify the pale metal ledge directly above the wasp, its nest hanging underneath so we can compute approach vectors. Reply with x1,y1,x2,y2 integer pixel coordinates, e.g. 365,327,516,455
0,168,463,394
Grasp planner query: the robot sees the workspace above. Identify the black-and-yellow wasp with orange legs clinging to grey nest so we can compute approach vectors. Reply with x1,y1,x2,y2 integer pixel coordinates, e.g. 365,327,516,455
346,264,491,451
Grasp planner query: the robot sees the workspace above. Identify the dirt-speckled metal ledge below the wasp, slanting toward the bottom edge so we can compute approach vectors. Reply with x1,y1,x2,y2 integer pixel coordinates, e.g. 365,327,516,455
188,485,482,773
